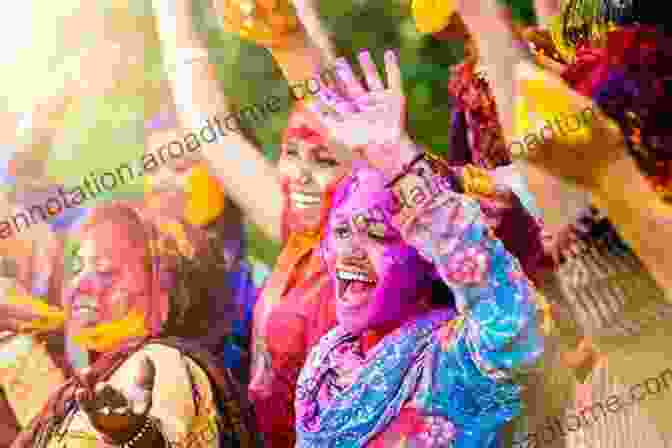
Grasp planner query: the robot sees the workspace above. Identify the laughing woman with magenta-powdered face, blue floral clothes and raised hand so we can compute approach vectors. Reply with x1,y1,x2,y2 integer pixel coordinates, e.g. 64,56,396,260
296,51,543,448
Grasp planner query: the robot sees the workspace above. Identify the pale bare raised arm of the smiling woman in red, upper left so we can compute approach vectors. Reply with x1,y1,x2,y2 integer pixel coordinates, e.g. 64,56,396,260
153,0,284,241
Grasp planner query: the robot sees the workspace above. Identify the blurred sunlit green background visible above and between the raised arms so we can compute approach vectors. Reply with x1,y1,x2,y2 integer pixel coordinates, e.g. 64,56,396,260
0,0,533,264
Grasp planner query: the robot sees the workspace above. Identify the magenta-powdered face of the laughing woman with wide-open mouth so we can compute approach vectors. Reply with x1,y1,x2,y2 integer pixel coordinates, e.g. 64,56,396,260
322,167,433,334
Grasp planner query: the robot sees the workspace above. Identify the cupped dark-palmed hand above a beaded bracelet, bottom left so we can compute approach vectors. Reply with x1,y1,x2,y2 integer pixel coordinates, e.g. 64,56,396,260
76,356,156,443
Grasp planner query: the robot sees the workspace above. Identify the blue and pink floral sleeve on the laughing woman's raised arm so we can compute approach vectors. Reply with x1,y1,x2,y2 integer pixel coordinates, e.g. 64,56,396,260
397,171,542,379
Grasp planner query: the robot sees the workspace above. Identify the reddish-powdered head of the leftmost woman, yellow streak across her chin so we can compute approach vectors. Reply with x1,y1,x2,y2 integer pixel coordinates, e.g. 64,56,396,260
64,207,168,352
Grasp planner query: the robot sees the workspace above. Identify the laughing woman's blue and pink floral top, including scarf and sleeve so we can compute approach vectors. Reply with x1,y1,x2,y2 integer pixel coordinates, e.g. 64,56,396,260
296,183,543,448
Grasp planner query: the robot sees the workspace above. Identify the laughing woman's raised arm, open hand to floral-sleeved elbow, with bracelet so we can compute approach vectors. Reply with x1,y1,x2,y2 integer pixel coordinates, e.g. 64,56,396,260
308,47,541,376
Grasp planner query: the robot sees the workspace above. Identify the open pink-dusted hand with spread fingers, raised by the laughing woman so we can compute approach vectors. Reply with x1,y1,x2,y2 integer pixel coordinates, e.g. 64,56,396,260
308,50,420,176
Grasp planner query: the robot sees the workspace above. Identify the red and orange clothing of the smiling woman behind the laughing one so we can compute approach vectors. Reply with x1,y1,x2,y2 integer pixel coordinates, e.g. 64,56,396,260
250,169,338,448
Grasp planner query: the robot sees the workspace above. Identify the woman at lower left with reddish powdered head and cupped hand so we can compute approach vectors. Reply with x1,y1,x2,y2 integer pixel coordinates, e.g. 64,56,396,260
13,204,255,448
